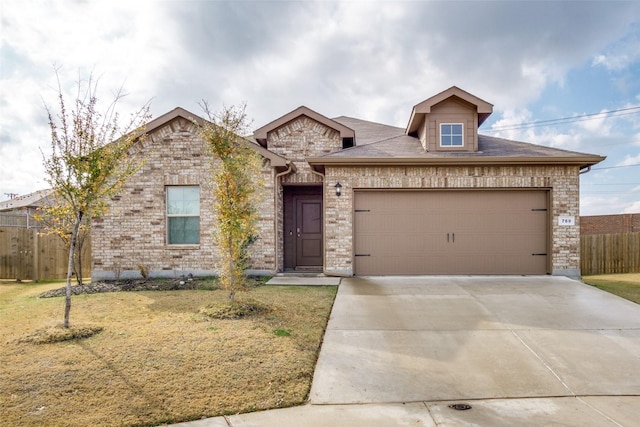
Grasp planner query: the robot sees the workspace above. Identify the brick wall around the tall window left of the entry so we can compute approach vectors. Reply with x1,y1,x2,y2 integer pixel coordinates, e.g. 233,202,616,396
91,118,275,280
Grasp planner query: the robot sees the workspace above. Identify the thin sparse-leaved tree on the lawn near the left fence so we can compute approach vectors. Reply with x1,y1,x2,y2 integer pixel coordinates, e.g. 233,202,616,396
43,70,150,328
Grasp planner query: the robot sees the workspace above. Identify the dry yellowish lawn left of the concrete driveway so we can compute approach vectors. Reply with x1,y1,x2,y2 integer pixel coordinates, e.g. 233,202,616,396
0,282,336,426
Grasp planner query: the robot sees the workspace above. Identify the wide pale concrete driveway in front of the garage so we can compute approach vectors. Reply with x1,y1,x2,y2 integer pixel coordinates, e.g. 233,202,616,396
171,276,640,427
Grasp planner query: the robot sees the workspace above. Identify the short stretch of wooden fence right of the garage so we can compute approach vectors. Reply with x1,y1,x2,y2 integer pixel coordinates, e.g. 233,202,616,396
580,233,640,276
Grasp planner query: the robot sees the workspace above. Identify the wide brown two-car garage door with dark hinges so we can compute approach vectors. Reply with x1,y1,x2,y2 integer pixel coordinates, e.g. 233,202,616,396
354,190,548,275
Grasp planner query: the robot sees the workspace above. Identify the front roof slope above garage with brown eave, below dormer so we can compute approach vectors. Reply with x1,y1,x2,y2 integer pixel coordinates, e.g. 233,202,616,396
307,133,605,169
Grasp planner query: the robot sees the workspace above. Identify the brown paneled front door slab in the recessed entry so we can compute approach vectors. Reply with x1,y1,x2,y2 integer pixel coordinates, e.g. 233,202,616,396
295,196,322,269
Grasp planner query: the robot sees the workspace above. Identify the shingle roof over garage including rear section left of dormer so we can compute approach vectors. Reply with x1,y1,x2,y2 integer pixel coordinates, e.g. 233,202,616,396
307,117,604,167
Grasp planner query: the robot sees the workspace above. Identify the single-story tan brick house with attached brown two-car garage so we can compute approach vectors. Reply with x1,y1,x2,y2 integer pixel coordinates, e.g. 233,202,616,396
92,87,604,280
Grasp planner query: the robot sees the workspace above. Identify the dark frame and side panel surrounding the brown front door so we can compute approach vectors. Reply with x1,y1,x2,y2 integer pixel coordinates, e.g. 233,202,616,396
282,183,325,272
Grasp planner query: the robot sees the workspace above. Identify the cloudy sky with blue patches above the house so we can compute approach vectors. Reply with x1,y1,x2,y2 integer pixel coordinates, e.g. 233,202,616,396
0,0,640,215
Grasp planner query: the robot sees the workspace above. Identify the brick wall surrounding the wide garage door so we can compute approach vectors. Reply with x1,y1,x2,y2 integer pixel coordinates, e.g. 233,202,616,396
325,166,580,276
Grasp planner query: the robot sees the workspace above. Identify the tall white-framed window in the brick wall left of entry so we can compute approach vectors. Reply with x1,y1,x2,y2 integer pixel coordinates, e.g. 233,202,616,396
167,186,200,245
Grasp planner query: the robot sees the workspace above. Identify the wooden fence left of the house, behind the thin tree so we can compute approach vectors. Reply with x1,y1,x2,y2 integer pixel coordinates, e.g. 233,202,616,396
0,227,91,280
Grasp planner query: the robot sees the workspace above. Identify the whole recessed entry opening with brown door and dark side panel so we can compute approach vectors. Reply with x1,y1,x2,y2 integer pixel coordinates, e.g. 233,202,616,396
284,186,323,271
